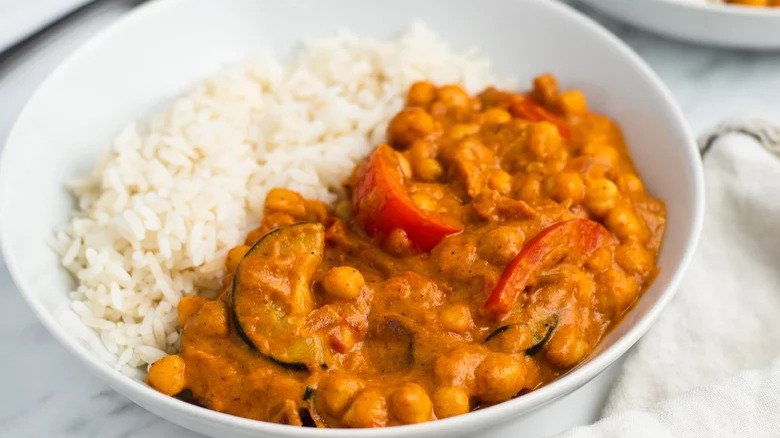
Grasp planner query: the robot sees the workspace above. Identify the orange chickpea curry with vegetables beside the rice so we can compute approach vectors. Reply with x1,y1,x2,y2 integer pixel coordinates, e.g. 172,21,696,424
148,75,665,427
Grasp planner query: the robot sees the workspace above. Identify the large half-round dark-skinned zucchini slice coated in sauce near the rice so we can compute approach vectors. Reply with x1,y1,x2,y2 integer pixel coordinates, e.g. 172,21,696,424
230,223,326,371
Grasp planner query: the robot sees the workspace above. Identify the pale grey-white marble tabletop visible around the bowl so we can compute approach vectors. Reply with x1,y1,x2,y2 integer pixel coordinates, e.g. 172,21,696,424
0,2,780,438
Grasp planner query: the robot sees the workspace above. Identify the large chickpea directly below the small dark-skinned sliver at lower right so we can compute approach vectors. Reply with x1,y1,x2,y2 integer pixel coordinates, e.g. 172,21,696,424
474,353,525,403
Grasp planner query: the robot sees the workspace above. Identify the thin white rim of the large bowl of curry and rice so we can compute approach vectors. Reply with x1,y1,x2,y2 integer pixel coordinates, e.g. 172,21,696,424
0,0,704,438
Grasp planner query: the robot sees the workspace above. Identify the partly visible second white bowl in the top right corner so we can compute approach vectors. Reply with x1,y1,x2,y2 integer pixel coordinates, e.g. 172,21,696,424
580,0,780,50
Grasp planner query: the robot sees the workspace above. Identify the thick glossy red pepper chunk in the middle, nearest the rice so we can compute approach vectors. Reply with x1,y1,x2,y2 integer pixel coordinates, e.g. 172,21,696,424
352,144,463,251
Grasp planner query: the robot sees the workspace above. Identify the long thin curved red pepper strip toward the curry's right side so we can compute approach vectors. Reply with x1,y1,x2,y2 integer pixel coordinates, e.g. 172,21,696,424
483,219,615,319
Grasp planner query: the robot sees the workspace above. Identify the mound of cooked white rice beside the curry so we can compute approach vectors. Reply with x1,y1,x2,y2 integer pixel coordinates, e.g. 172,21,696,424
53,24,508,376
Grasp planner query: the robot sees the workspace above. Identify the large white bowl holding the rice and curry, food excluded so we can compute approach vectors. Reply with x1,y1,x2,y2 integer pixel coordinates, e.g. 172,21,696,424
0,0,704,437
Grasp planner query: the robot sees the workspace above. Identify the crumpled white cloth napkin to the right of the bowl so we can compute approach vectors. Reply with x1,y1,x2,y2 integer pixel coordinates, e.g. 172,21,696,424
561,121,780,438
